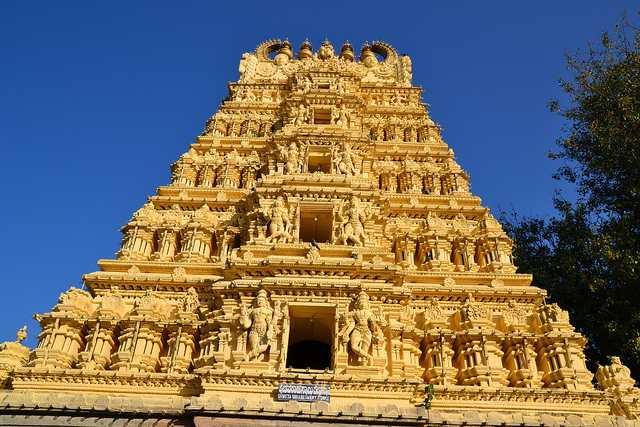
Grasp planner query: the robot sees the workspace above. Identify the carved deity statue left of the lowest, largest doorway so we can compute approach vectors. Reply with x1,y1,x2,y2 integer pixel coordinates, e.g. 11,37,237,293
239,289,280,361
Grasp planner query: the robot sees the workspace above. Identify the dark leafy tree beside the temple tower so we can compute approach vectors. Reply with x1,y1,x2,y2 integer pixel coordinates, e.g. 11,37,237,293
503,13,640,376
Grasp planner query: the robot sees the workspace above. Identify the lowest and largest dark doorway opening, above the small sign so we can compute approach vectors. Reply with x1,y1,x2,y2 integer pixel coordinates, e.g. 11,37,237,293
287,306,335,370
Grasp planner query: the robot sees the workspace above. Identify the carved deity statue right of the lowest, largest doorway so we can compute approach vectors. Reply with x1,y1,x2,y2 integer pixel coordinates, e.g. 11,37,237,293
339,291,383,364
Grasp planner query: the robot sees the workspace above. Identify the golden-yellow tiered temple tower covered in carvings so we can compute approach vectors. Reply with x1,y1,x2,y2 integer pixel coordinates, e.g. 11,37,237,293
0,40,640,426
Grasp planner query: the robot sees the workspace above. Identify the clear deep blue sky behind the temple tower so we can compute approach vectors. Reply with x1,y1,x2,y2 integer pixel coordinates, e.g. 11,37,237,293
0,0,638,345
